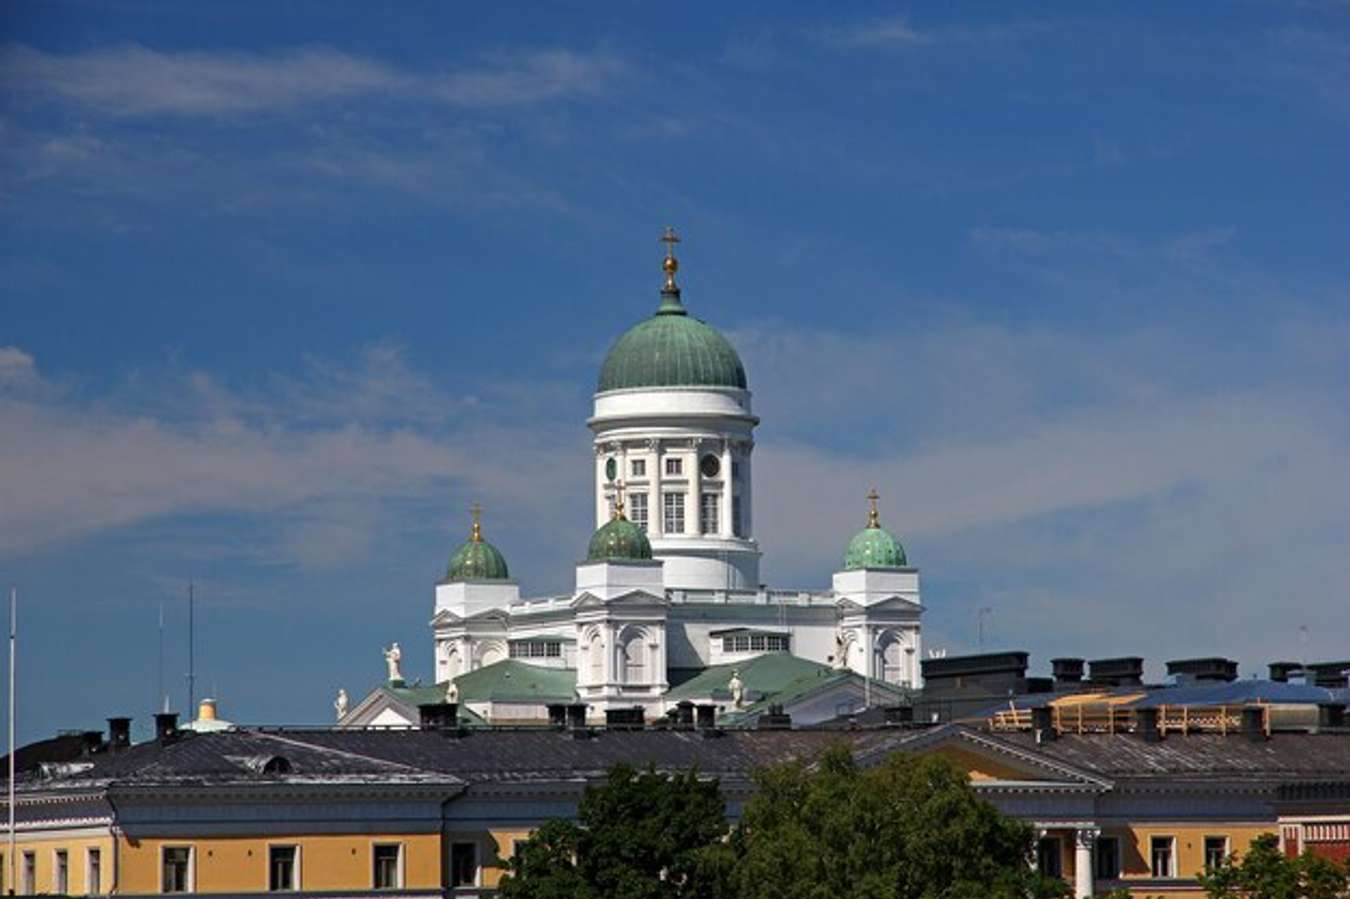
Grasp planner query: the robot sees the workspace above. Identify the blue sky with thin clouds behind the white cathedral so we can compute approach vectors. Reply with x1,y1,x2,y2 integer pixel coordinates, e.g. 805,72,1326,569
0,0,1350,737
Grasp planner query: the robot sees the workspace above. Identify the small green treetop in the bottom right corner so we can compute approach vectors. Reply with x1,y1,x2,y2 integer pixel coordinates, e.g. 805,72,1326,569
1200,833,1350,899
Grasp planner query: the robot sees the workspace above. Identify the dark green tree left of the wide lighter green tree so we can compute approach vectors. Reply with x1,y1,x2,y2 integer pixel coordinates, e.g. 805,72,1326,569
501,765,732,899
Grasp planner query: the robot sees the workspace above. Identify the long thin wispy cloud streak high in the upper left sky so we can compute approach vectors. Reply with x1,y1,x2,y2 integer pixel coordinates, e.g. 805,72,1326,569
0,45,624,116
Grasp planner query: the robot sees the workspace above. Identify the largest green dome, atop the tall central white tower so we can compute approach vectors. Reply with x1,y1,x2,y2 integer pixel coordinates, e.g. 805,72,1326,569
595,290,745,393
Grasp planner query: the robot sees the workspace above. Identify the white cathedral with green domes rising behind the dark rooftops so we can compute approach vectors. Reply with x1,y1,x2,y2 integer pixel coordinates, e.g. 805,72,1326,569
336,229,923,725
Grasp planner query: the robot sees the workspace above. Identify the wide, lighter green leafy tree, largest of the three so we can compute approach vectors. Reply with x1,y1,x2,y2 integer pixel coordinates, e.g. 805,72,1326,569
732,746,1068,899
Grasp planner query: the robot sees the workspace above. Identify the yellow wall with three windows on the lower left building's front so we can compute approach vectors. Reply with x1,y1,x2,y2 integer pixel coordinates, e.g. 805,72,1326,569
117,833,441,892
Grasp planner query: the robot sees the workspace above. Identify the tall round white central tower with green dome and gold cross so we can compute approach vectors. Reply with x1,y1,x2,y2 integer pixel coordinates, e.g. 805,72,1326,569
587,228,760,590
